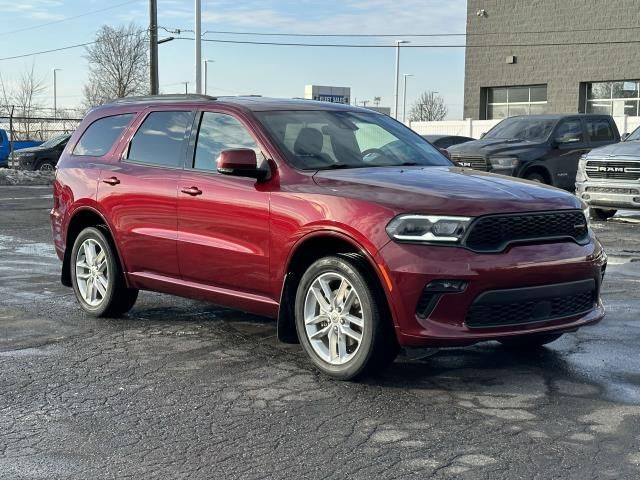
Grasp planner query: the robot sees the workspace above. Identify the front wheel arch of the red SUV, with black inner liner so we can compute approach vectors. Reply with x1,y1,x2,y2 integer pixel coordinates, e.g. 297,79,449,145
277,230,393,343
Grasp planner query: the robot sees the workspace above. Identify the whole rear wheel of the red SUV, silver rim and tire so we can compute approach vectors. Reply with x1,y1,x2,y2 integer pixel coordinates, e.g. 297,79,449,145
70,227,138,317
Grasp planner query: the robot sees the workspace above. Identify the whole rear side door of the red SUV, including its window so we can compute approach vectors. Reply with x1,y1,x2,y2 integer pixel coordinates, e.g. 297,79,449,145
98,108,194,278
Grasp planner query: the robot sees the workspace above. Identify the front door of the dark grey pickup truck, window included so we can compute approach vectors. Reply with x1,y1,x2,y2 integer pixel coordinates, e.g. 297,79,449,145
547,117,589,191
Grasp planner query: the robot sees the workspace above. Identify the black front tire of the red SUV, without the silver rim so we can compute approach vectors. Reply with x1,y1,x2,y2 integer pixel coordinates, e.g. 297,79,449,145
295,255,399,380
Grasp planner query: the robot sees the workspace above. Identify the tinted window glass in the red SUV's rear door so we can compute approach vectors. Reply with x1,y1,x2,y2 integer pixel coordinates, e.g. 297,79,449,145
127,112,193,167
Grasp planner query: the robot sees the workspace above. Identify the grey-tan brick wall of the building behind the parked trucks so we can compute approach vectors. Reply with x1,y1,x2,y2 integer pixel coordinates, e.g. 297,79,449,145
464,0,640,119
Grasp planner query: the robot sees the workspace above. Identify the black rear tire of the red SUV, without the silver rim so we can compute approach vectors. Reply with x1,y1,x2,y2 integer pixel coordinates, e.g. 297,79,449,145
69,227,138,317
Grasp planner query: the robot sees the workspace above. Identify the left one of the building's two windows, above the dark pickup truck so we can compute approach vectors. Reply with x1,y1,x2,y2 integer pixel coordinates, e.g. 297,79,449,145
486,85,547,120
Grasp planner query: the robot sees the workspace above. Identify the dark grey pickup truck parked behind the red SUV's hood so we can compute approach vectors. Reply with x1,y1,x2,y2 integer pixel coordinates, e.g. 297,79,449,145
448,114,620,191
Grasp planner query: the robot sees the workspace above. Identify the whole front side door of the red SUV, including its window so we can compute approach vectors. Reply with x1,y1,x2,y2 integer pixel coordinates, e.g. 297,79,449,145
178,112,270,294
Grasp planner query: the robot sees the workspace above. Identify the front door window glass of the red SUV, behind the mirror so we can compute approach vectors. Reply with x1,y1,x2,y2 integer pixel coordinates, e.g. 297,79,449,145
193,112,262,171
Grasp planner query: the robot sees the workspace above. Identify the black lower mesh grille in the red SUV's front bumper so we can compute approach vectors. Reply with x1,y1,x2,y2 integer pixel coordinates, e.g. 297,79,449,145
465,282,596,328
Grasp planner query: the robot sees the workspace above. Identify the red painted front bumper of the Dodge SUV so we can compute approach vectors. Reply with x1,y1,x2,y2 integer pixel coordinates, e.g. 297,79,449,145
380,239,606,347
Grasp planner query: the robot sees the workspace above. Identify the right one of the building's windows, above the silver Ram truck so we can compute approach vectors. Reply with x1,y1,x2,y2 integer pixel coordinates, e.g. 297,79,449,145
585,80,640,117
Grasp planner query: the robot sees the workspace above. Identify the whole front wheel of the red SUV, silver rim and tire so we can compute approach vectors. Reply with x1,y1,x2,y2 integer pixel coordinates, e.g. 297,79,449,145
295,256,397,380
